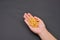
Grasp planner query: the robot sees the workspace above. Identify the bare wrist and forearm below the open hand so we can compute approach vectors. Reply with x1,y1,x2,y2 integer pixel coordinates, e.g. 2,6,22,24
38,28,57,40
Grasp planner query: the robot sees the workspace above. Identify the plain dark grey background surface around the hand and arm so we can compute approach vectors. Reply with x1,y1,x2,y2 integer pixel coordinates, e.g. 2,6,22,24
0,0,60,40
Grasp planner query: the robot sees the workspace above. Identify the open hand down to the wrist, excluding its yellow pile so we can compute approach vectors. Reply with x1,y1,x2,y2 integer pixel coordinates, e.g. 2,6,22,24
24,13,45,34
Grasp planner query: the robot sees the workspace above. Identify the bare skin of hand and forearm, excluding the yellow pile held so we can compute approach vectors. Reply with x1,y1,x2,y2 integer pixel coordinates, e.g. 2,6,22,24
24,13,57,40
